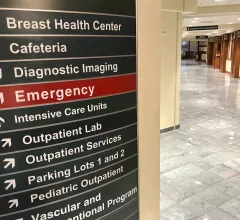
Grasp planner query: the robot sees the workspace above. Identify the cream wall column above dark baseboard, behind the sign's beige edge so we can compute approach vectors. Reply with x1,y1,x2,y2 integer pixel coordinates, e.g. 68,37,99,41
160,11,182,129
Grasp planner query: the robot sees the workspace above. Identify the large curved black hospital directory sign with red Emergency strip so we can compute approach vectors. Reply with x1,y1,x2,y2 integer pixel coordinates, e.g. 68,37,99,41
0,0,139,220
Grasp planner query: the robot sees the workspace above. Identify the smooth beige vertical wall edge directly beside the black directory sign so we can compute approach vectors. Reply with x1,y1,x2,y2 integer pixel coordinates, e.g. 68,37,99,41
137,0,161,220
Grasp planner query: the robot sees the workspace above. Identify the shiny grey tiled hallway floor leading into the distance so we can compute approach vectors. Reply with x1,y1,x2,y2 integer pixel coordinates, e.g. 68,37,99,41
161,61,240,220
